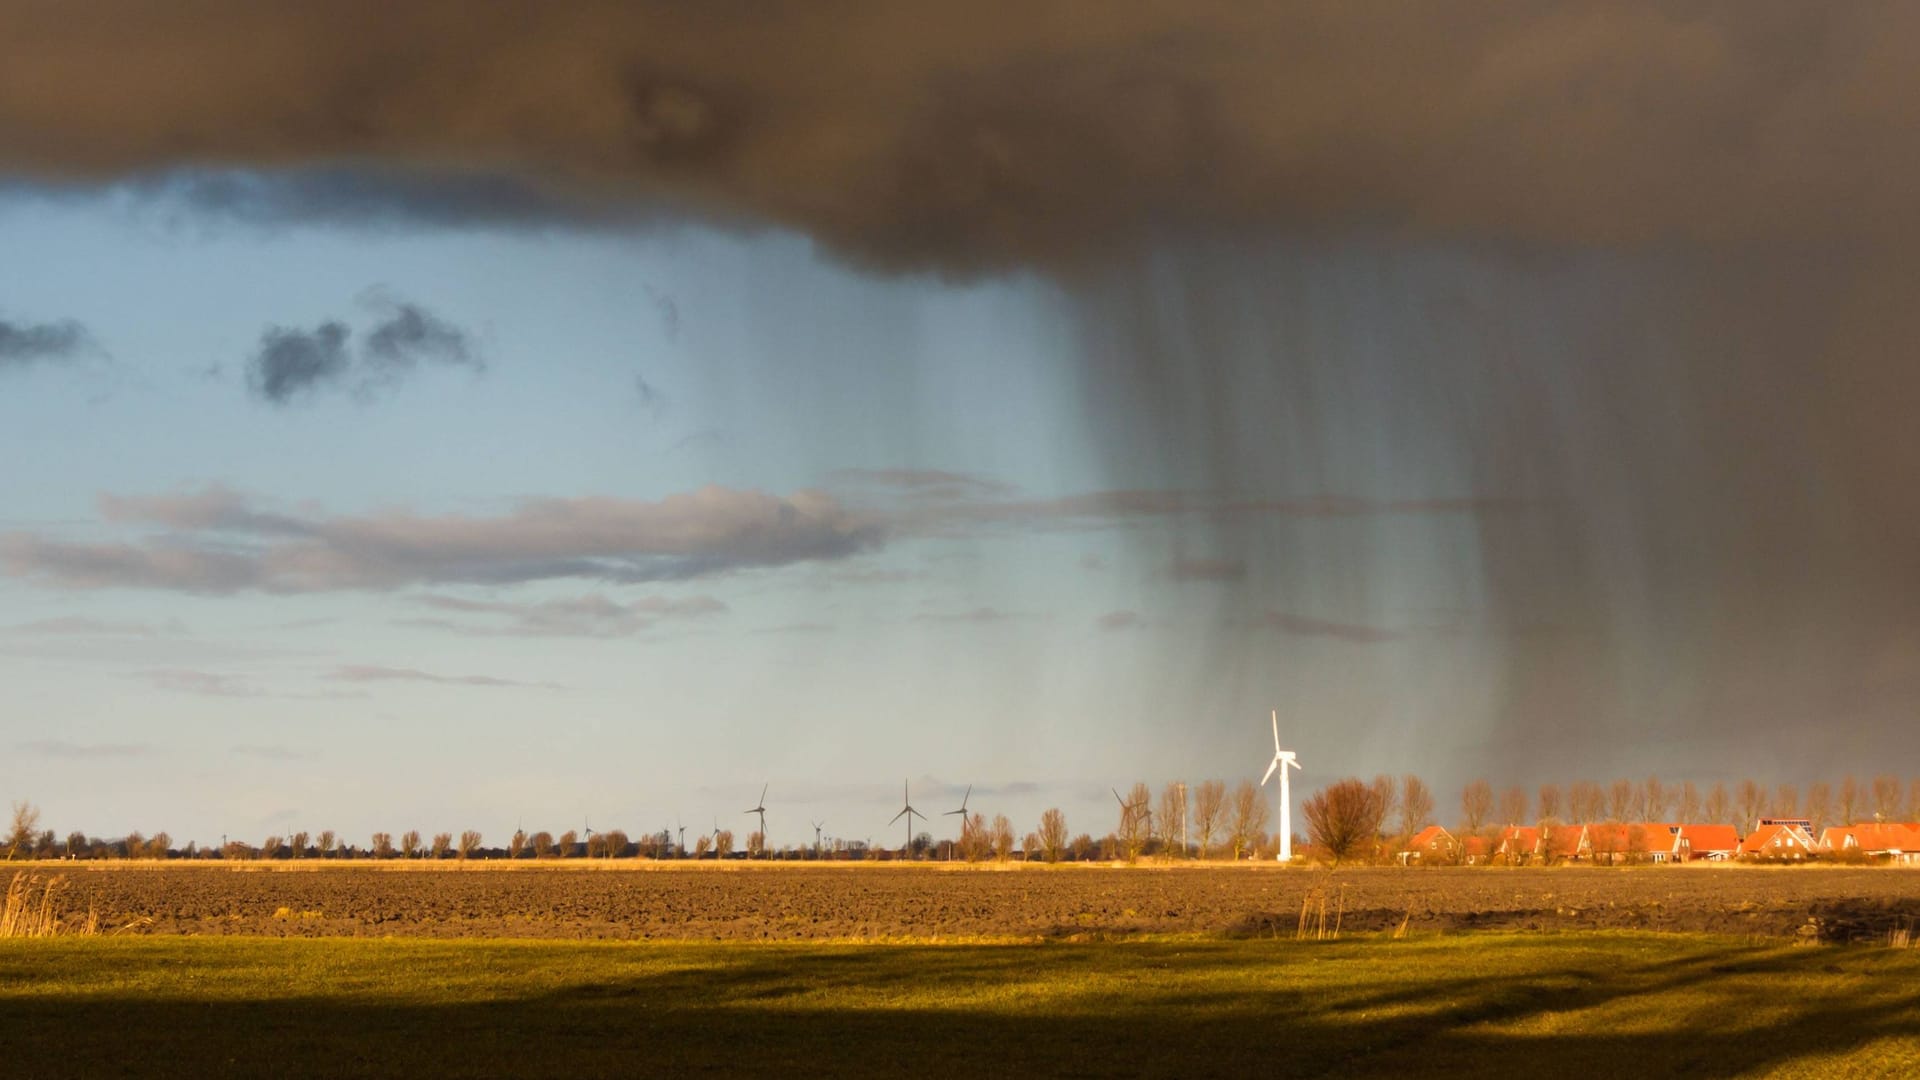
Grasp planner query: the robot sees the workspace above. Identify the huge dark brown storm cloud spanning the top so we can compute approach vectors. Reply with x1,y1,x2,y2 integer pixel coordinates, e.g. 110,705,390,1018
0,0,1920,271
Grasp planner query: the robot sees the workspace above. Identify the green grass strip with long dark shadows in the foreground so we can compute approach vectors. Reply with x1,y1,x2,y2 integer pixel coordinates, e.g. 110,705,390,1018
0,934,1920,1080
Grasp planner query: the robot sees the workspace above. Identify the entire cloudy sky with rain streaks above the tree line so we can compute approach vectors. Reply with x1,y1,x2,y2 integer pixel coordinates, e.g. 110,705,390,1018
0,0,1920,844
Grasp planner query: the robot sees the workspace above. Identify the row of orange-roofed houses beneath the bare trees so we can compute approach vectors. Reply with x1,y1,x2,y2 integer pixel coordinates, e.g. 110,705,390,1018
1400,817,1920,865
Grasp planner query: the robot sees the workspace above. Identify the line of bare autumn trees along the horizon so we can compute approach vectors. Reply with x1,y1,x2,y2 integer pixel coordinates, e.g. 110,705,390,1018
4,773,1920,863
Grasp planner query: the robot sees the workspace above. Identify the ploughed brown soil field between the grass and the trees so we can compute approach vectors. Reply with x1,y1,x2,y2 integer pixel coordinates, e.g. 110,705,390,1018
40,863,1920,942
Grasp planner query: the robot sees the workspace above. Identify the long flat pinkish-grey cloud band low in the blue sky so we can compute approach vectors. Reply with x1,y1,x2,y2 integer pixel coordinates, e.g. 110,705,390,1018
0,486,879,591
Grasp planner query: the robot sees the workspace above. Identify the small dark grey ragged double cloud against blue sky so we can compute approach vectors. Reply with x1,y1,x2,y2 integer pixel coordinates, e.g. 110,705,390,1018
248,288,486,405
